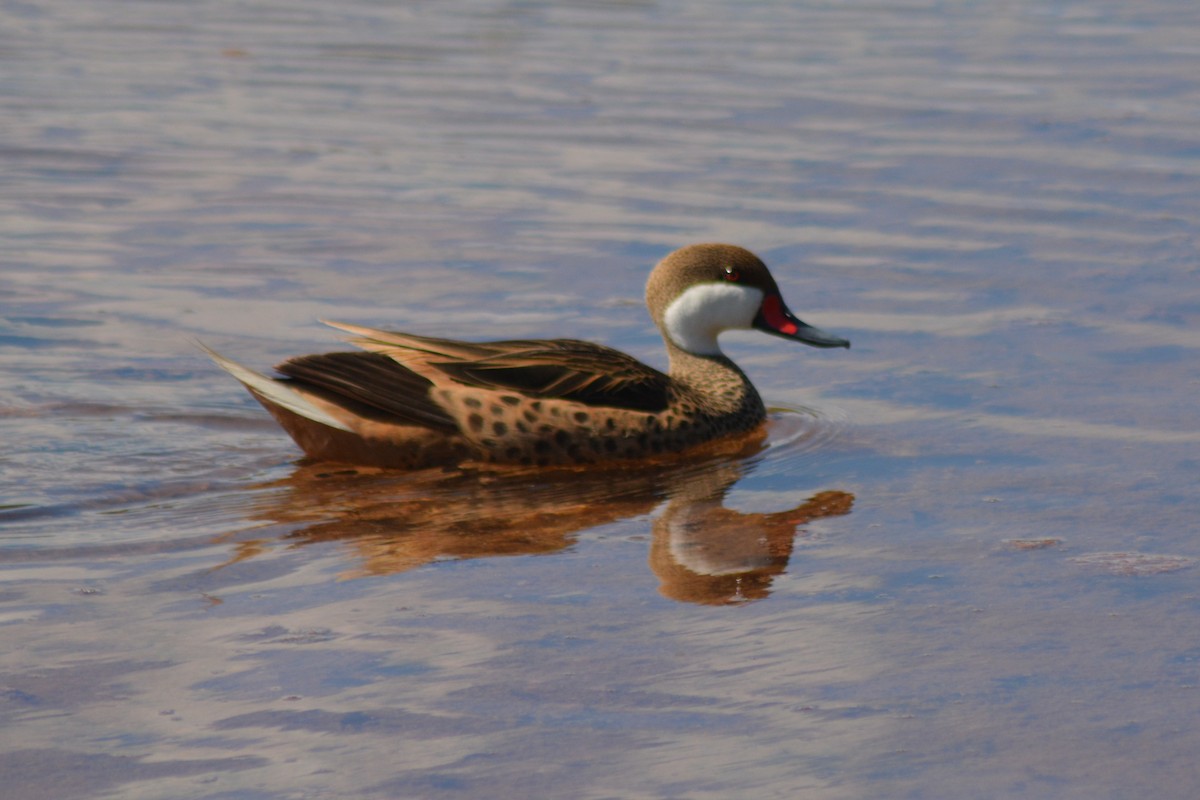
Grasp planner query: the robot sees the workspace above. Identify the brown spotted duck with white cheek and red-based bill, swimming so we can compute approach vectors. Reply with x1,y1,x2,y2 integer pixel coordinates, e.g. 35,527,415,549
202,243,850,469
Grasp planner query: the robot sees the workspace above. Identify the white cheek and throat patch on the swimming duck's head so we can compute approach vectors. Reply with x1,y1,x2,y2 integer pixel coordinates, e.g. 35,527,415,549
662,283,762,355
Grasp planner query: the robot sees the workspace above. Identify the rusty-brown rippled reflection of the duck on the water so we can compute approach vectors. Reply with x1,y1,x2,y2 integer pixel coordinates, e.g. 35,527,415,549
248,437,853,604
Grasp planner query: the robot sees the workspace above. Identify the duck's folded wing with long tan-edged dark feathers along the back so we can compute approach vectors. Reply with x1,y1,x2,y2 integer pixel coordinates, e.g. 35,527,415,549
329,323,671,413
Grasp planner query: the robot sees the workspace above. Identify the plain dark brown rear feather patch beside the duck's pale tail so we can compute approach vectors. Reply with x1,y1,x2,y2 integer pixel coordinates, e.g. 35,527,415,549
276,353,458,433
